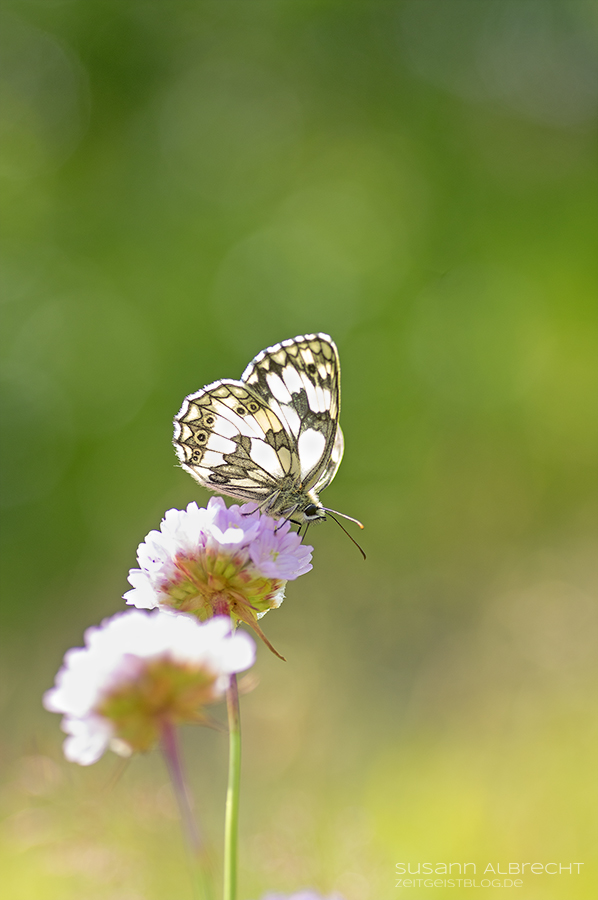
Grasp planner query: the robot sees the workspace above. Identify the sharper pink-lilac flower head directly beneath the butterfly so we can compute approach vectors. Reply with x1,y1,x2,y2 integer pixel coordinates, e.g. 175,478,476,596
124,497,312,643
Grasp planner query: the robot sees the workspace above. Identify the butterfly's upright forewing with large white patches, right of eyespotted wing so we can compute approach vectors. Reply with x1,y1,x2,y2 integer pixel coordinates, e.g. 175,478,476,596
241,334,343,492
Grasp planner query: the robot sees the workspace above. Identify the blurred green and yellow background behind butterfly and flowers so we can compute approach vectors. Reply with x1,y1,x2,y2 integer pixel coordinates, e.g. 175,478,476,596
0,0,598,900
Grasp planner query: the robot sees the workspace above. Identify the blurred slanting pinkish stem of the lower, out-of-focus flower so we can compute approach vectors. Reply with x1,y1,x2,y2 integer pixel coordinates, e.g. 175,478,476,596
160,721,213,900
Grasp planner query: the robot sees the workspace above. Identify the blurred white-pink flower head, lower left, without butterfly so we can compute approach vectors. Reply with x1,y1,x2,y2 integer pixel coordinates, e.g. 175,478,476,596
44,610,255,766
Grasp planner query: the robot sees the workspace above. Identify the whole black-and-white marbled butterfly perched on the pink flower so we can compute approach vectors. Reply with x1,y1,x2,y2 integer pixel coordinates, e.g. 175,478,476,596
173,334,363,552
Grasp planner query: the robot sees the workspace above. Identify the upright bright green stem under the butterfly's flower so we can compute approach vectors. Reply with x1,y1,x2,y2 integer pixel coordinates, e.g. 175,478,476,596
223,675,241,900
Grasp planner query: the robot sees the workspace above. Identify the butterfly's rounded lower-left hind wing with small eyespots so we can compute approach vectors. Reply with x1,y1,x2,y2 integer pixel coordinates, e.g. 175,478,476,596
174,379,299,503
